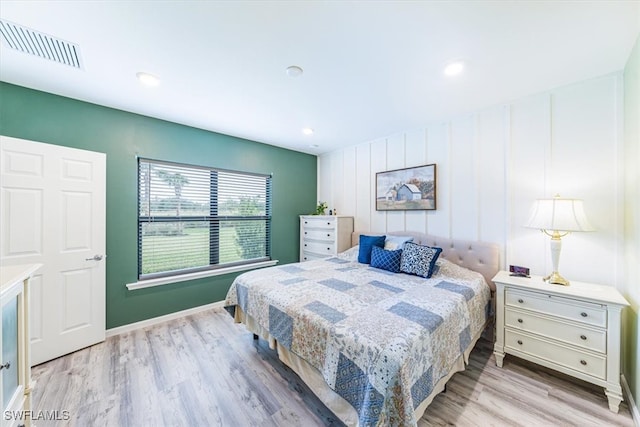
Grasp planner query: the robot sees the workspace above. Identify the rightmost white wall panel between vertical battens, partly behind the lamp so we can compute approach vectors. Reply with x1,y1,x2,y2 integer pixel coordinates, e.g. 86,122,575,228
551,77,623,284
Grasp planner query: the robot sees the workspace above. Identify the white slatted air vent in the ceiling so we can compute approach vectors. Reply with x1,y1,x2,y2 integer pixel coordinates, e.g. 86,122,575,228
0,20,82,69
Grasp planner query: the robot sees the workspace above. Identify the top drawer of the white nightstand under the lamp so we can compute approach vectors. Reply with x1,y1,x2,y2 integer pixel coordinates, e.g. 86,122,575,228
505,288,607,328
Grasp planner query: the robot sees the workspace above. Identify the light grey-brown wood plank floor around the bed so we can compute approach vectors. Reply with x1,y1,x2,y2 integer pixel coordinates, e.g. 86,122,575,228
32,309,633,427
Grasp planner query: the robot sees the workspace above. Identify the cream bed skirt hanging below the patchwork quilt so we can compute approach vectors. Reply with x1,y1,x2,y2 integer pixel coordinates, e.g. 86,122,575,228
234,306,482,426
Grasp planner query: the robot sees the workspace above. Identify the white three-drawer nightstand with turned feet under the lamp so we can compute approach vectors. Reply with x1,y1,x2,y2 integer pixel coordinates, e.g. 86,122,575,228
493,271,629,412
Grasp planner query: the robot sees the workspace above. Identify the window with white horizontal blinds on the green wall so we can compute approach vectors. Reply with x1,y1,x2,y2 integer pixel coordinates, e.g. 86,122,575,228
138,159,271,280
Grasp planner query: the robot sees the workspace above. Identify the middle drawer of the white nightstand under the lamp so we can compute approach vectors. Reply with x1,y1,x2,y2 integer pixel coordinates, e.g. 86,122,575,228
504,308,607,354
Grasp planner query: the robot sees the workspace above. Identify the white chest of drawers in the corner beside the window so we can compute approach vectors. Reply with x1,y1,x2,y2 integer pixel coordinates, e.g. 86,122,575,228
300,215,353,262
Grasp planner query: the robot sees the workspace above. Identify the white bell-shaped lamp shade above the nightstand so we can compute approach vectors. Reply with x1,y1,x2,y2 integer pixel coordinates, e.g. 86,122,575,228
525,197,594,231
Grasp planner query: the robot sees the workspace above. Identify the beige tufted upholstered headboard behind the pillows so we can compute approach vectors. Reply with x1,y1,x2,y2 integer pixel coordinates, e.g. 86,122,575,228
351,231,500,290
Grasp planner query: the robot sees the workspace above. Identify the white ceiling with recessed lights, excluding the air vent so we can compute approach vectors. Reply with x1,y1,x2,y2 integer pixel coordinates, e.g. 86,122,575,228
0,0,640,154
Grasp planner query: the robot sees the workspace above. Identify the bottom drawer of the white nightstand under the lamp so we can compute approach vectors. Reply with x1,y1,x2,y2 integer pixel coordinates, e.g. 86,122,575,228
505,329,607,379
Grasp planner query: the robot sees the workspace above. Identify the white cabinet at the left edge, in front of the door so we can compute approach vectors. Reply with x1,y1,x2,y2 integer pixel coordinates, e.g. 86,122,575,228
0,264,40,427
